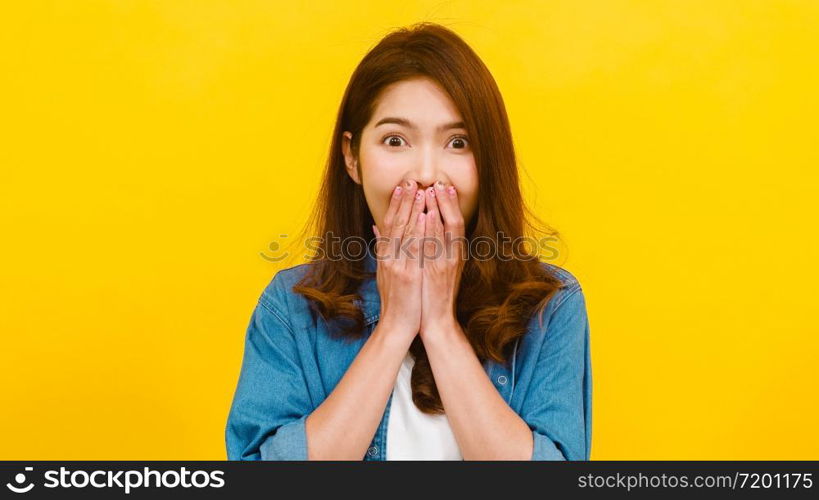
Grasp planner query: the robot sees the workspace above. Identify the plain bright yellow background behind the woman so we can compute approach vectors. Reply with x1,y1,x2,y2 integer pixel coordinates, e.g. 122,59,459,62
0,0,819,460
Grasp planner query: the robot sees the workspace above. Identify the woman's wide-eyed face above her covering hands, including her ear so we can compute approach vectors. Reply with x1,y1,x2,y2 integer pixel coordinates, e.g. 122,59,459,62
342,78,478,234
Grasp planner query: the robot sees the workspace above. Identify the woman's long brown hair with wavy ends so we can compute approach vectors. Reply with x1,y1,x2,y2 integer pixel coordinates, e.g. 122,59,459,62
293,22,560,414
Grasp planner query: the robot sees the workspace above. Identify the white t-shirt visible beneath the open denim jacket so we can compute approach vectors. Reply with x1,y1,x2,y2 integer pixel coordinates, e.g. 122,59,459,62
387,352,463,460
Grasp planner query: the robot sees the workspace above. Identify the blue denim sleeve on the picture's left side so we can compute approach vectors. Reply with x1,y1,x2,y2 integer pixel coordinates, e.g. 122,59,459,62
225,288,311,460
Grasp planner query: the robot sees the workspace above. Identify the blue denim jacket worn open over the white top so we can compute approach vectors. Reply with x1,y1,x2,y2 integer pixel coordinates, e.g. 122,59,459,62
225,254,592,460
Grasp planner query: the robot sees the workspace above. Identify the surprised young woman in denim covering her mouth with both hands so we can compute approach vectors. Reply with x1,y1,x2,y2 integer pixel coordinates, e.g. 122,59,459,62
226,23,591,460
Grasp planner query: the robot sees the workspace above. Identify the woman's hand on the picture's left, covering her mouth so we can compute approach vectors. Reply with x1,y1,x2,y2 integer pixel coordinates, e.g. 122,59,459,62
373,180,425,346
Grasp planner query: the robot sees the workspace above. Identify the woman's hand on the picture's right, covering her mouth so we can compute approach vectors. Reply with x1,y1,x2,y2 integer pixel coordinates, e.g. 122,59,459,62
419,181,466,340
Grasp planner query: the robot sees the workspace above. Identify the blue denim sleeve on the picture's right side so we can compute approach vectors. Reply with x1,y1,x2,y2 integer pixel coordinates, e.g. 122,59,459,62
521,283,591,460
